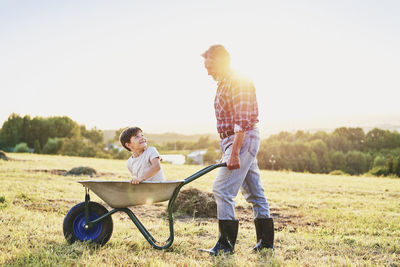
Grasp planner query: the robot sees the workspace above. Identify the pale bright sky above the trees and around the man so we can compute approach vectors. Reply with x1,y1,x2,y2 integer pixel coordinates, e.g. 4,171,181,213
0,0,400,134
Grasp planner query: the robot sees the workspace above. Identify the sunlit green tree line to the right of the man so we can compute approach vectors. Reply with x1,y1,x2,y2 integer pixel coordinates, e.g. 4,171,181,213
258,127,400,177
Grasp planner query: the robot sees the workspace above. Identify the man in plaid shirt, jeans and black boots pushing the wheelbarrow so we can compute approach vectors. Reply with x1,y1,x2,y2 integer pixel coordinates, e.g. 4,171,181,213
202,45,274,255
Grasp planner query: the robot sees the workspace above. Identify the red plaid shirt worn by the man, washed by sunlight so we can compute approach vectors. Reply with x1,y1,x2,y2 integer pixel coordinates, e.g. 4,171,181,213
214,75,258,133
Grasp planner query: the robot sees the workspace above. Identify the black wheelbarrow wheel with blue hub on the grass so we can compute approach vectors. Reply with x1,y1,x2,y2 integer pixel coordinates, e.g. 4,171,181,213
63,202,113,245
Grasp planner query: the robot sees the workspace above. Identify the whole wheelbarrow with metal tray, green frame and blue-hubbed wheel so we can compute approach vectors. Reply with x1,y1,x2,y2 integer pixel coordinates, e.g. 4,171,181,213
63,163,226,250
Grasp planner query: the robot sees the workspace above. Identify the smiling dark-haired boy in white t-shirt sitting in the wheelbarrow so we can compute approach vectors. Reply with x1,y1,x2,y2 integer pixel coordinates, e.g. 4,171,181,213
119,127,165,184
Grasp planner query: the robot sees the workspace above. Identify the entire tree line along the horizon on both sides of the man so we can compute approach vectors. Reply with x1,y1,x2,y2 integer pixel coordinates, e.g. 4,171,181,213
0,113,400,177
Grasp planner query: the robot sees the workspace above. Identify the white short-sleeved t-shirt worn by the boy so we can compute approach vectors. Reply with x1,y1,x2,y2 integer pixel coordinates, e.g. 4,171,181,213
126,146,165,182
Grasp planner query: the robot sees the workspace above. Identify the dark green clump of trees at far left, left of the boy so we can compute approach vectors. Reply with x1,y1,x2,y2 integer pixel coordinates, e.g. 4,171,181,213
0,113,129,158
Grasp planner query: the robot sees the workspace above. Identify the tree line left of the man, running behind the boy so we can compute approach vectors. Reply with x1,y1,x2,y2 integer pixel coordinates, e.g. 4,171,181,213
0,113,219,163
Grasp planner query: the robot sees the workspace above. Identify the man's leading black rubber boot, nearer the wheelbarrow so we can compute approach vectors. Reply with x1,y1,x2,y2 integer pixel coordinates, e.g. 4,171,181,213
202,220,239,256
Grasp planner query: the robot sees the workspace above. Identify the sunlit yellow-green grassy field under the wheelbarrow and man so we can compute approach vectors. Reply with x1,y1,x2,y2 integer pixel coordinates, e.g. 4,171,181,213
0,153,400,266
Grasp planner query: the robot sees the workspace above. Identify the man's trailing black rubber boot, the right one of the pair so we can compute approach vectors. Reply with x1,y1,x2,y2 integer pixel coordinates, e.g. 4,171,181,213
253,218,274,251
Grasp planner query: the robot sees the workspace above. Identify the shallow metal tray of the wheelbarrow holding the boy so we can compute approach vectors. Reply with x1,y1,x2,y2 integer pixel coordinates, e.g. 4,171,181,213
78,180,184,208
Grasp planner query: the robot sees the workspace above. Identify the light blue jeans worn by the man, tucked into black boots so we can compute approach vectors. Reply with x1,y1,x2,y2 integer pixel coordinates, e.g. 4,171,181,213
213,128,270,220
